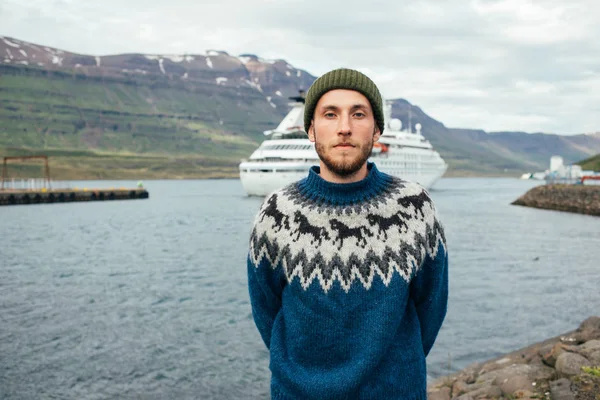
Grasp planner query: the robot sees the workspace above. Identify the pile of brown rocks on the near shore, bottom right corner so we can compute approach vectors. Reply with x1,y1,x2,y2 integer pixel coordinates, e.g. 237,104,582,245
427,317,600,400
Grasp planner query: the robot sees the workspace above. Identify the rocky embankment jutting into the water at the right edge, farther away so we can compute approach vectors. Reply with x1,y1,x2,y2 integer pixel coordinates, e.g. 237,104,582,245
512,184,600,216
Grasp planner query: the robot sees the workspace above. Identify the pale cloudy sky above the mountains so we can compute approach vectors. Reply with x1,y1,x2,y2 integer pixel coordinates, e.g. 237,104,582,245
0,0,600,134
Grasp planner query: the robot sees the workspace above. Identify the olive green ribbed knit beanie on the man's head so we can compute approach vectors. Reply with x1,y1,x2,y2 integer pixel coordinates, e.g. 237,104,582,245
304,68,384,133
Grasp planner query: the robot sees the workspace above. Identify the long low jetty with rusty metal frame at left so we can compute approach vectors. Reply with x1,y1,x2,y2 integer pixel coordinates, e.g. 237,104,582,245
0,156,150,206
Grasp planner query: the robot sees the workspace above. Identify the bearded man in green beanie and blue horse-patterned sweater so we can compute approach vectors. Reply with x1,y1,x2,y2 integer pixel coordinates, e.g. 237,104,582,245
248,69,448,400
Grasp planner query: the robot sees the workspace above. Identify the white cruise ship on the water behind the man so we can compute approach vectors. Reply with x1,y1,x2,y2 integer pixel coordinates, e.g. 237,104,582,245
239,93,448,197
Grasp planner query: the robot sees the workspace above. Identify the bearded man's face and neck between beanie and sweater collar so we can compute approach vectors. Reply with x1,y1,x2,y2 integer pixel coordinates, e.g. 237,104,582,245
308,89,380,181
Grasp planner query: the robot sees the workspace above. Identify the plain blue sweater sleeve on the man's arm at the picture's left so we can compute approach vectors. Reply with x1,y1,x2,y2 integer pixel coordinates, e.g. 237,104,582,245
248,245,283,349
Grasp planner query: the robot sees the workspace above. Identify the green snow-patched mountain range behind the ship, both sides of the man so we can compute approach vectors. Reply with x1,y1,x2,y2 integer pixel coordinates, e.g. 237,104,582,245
0,36,600,178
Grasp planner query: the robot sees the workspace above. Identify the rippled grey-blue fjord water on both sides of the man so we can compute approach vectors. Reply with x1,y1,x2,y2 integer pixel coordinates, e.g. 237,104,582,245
0,179,600,400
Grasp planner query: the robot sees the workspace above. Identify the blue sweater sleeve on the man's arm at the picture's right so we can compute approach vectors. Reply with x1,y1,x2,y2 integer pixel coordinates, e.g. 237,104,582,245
410,219,448,356
